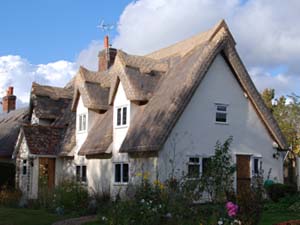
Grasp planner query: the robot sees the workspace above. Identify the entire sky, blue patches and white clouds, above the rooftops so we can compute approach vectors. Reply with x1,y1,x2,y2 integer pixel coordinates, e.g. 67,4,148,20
0,0,300,107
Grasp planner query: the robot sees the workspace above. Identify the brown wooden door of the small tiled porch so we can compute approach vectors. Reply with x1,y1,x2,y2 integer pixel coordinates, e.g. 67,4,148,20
39,158,55,188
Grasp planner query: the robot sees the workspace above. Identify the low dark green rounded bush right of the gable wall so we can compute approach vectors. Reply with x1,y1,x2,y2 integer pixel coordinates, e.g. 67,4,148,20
266,183,297,202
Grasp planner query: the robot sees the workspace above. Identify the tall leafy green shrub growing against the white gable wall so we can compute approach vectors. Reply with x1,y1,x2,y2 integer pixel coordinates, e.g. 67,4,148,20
200,137,236,203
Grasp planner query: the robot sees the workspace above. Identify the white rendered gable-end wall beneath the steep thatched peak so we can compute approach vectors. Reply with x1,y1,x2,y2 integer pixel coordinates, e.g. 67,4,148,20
158,55,283,185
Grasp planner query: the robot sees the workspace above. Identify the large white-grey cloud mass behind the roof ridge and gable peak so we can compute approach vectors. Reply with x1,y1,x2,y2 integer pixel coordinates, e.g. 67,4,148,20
78,0,300,94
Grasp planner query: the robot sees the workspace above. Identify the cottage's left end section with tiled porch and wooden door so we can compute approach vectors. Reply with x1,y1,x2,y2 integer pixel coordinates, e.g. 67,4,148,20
13,82,75,198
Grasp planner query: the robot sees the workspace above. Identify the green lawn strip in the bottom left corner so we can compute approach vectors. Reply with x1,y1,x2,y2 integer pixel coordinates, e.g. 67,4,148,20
0,207,67,225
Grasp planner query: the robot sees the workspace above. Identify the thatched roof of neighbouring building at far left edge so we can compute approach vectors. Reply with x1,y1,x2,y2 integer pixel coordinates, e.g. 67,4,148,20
0,108,28,158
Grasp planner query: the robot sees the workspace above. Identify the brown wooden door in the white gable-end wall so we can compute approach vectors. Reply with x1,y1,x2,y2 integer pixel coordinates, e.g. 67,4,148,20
236,155,251,193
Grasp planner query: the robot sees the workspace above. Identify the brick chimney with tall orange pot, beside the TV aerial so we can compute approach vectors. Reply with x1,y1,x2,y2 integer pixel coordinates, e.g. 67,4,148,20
98,35,117,72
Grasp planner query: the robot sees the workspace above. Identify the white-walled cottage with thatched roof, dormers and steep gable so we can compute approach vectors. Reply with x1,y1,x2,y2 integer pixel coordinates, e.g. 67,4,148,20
11,21,287,197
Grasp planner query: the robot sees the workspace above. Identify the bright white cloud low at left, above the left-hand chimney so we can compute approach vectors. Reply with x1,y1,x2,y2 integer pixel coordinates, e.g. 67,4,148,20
0,55,77,107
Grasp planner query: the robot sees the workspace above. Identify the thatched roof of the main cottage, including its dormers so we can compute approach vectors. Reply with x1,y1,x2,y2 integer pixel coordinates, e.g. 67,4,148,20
72,21,287,156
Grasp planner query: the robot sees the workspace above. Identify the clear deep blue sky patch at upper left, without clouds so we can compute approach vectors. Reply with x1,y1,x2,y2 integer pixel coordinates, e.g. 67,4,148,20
0,0,130,64
